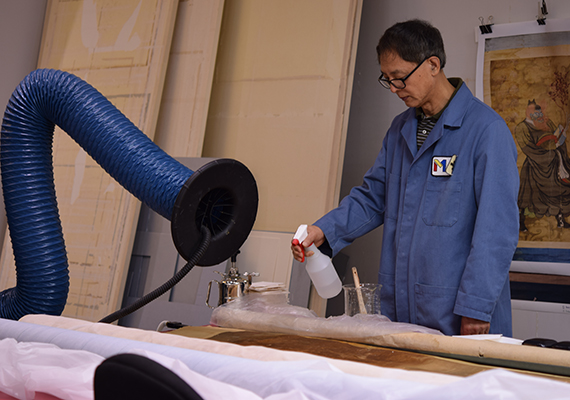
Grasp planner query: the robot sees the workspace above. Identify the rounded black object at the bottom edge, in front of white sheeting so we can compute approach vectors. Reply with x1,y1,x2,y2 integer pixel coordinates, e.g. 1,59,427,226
93,354,203,400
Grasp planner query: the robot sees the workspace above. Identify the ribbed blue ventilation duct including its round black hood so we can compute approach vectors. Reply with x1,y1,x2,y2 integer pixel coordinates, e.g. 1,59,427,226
0,69,258,319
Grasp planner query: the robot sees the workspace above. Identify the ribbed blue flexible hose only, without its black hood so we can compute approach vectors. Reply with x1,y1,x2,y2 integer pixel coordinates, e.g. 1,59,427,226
0,69,193,319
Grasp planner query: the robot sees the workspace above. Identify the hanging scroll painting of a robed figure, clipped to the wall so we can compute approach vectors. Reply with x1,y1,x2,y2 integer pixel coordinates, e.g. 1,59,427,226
476,20,570,262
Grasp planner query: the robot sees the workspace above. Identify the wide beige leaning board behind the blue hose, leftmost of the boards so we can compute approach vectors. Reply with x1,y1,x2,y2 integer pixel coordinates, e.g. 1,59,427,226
0,0,178,321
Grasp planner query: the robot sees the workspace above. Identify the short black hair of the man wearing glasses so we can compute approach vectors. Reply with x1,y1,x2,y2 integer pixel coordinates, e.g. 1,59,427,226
376,19,445,68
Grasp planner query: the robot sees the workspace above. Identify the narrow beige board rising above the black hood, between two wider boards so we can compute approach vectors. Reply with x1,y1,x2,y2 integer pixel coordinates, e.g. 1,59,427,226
154,0,224,157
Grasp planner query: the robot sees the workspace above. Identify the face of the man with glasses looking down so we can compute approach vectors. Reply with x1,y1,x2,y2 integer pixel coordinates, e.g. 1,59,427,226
380,53,433,111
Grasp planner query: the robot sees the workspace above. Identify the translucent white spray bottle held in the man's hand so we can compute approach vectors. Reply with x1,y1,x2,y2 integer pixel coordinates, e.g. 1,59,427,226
292,225,342,299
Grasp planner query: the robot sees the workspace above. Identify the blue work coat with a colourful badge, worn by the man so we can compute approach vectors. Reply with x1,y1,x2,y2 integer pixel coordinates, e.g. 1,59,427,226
315,80,519,336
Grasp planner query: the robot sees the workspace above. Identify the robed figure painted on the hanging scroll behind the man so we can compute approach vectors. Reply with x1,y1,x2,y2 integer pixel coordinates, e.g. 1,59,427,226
515,100,570,232
